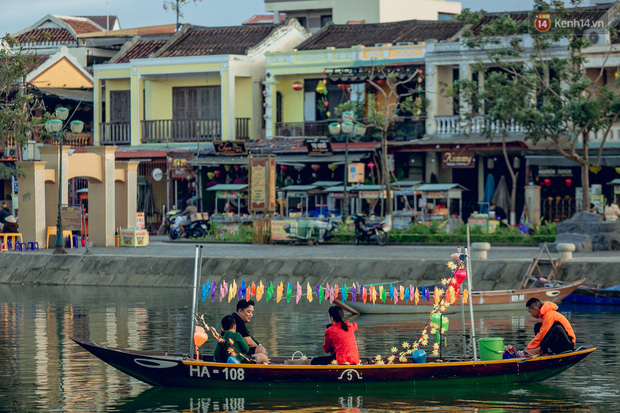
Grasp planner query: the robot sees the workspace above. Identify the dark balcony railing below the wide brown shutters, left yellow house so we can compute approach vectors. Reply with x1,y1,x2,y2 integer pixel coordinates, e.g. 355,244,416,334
141,119,222,143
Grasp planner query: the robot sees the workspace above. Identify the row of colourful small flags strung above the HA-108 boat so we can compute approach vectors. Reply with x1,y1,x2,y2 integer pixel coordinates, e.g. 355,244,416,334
202,262,469,305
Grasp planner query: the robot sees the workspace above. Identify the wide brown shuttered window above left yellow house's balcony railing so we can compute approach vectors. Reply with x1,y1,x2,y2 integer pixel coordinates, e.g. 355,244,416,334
172,86,222,120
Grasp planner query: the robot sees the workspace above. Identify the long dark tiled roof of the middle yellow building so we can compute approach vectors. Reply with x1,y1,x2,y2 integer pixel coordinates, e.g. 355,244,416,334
297,20,464,50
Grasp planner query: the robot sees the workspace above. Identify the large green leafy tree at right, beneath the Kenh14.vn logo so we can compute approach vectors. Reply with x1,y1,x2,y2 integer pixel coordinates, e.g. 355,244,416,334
457,0,620,210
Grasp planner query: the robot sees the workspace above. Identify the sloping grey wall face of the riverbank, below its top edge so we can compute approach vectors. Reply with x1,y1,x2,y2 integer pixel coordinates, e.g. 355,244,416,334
0,252,618,290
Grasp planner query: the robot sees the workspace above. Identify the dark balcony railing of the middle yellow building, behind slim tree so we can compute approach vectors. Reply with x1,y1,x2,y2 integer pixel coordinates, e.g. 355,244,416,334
276,116,425,141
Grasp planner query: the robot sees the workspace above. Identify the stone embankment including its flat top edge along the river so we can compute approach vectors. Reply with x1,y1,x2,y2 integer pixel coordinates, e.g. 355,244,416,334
0,243,620,290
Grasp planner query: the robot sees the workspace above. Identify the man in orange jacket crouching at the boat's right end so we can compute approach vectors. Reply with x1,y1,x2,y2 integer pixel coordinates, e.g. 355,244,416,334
525,298,576,356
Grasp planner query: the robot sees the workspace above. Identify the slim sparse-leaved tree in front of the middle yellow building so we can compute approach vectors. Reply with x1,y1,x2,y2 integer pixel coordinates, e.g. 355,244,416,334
336,65,424,225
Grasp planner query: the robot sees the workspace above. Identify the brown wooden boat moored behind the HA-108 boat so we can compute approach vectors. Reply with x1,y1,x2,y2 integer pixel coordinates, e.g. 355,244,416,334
334,278,585,314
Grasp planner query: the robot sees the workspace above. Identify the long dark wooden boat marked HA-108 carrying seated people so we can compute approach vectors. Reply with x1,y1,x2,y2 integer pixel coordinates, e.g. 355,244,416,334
72,338,596,388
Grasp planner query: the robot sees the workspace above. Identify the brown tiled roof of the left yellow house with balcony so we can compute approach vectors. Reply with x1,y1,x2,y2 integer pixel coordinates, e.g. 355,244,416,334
158,24,277,57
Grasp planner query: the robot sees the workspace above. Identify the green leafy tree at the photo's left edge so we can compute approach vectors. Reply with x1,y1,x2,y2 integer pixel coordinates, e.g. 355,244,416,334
0,35,49,178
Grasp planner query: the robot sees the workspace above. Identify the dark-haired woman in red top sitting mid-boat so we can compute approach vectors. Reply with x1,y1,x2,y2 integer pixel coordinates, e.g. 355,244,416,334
285,305,360,365
